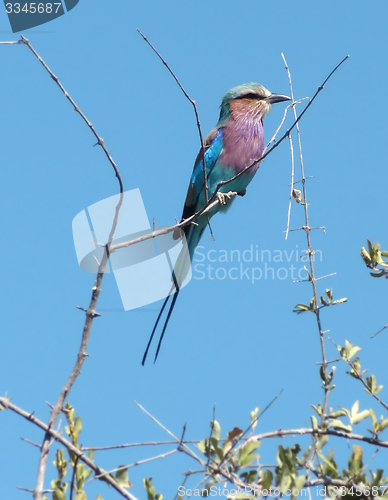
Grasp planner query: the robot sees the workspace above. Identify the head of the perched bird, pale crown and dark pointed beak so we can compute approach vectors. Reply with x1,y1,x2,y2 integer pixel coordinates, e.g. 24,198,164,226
218,83,290,126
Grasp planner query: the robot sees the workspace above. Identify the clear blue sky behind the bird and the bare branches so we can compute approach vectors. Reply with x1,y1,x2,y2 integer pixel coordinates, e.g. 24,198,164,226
0,0,388,500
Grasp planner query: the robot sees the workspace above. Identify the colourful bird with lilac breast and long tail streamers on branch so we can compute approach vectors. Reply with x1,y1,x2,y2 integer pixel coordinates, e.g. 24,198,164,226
142,83,291,366
